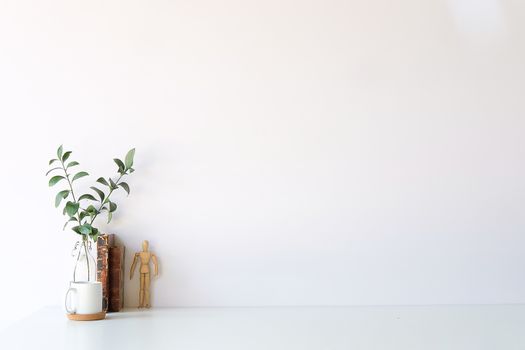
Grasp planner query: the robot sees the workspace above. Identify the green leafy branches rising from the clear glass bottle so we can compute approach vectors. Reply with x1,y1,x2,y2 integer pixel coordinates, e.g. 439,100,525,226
46,146,135,241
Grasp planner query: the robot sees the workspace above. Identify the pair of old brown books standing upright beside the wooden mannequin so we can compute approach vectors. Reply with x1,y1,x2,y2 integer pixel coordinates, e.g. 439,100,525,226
97,234,125,312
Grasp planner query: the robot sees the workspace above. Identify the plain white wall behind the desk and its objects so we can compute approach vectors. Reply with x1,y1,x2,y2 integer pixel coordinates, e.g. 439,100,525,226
0,0,525,328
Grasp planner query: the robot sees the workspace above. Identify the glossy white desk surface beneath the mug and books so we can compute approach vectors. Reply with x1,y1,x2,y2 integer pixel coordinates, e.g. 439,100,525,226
0,305,525,350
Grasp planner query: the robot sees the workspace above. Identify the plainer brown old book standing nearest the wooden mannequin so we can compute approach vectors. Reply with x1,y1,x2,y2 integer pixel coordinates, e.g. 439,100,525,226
108,246,125,312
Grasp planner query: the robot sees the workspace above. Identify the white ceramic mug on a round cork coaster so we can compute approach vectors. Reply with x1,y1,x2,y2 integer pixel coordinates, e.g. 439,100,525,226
65,282,102,315
